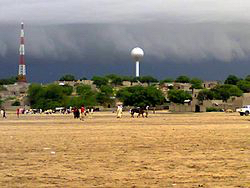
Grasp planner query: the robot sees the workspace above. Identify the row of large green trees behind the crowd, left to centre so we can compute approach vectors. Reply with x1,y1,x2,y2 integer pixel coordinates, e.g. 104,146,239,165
28,84,165,110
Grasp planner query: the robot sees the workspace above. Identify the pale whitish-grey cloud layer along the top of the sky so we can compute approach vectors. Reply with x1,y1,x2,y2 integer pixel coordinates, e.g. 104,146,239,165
0,0,250,24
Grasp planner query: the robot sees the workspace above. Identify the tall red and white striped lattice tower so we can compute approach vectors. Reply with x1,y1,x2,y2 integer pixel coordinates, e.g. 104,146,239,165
18,22,27,82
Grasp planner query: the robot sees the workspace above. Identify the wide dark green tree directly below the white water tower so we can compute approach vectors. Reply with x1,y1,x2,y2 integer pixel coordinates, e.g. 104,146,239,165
116,86,165,107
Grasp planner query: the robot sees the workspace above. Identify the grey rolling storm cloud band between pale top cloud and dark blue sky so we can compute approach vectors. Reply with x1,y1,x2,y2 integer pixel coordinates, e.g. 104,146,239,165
0,22,250,63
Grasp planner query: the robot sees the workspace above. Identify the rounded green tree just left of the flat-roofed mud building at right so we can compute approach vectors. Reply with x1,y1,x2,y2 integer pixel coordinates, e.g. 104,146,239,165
168,89,192,104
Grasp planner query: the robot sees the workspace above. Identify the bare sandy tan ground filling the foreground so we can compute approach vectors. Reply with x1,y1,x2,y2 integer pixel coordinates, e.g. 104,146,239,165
0,112,250,188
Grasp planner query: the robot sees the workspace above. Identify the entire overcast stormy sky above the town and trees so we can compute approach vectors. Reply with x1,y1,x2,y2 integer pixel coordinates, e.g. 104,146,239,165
0,0,250,82
